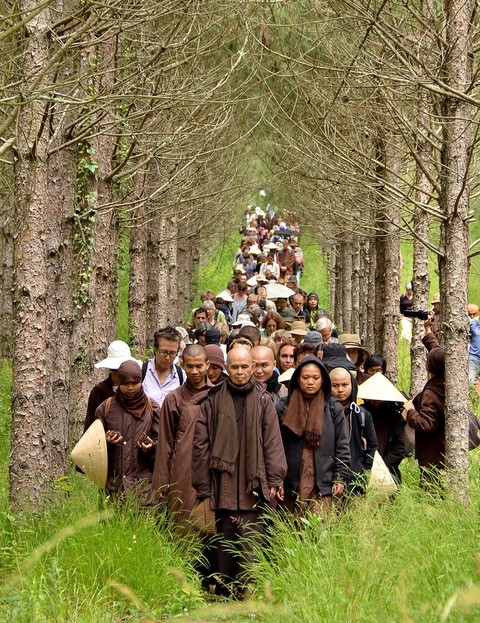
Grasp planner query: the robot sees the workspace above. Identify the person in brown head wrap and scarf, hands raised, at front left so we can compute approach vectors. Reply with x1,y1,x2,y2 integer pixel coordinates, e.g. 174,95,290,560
95,361,160,503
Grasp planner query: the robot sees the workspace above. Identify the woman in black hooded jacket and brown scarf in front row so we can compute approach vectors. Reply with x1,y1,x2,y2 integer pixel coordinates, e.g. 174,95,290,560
281,355,350,512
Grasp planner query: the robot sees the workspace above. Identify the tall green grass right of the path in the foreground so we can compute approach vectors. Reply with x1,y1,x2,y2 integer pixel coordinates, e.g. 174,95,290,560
246,460,480,623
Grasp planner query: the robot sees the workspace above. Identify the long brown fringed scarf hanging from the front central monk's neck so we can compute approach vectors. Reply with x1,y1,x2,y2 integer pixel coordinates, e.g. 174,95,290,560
210,378,261,493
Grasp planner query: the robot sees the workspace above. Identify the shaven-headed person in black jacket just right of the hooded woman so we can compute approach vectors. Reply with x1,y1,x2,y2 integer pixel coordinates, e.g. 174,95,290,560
330,368,378,493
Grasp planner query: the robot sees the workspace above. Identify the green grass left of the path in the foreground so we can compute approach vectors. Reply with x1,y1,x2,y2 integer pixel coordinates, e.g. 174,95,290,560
0,480,203,623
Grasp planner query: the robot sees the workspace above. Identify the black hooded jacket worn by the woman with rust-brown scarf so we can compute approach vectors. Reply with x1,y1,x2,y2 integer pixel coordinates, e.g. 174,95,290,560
280,355,350,496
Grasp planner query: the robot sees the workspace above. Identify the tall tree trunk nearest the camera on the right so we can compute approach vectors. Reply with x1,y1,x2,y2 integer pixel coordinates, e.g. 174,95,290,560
439,0,473,501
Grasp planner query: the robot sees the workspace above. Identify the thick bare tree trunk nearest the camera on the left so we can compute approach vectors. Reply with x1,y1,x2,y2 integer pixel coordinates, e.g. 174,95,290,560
10,0,53,509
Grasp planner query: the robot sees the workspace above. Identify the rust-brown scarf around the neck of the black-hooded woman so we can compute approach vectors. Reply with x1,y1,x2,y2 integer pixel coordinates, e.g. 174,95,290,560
282,388,325,448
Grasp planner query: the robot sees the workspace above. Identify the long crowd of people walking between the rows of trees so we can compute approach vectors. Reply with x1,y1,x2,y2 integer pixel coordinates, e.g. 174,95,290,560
76,207,480,594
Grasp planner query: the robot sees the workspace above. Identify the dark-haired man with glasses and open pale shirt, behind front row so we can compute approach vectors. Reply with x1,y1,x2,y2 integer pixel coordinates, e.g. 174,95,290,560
142,327,185,405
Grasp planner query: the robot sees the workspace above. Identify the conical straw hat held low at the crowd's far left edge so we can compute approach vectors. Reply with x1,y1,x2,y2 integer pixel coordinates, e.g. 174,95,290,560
70,420,108,489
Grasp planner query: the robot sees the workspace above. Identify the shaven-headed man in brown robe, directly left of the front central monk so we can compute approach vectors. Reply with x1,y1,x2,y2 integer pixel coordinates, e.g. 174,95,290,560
152,344,212,522
